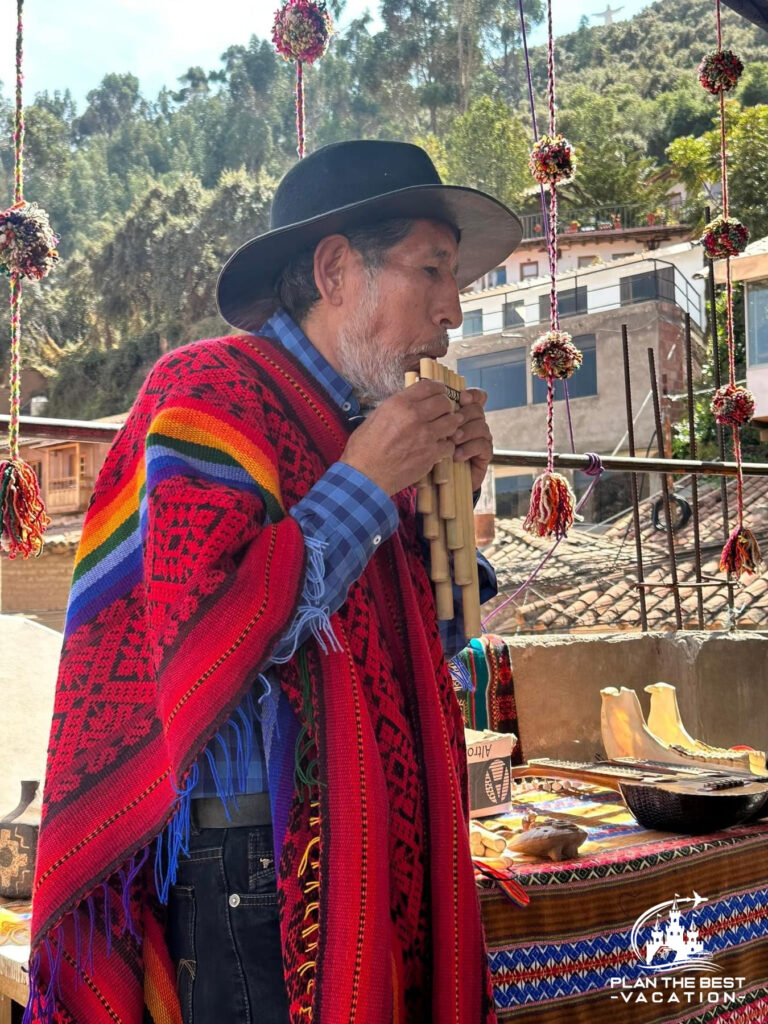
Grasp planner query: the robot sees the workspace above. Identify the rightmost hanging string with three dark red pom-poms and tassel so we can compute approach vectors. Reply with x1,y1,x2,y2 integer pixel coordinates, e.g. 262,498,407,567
698,0,763,579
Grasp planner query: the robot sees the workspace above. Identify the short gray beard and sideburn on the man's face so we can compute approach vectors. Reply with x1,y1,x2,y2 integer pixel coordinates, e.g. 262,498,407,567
339,272,447,406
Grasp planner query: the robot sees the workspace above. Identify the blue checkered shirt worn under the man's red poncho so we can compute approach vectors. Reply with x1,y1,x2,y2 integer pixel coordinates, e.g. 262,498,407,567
195,309,497,797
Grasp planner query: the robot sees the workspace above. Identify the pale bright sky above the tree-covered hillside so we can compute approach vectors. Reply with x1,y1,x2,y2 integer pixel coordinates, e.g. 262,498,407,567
0,0,650,111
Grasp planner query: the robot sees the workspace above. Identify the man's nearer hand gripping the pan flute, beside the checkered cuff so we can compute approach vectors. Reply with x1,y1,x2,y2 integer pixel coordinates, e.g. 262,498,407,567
340,380,462,495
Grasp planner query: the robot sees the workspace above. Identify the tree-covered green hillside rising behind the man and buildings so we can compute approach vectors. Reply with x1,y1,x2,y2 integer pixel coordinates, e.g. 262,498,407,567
0,0,768,417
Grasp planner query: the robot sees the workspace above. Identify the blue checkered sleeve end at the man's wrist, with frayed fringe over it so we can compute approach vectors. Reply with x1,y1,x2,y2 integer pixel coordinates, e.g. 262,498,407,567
290,462,398,584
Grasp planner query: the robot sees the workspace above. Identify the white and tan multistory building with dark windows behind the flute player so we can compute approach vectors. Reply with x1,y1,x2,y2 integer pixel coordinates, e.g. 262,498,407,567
456,242,706,520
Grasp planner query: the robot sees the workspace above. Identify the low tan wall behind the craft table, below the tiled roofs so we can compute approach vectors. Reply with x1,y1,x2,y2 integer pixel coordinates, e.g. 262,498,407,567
507,632,768,761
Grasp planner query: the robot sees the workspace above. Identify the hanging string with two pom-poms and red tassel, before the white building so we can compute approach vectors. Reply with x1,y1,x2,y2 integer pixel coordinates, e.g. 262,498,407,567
523,0,582,540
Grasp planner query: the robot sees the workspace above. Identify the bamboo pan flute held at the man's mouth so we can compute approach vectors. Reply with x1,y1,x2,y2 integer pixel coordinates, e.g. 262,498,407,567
406,359,482,640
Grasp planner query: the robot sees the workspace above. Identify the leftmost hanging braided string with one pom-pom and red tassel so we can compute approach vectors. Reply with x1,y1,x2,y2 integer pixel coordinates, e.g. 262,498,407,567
0,0,52,558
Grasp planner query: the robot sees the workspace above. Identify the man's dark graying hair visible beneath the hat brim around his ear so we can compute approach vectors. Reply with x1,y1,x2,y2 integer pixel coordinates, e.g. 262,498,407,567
274,218,414,325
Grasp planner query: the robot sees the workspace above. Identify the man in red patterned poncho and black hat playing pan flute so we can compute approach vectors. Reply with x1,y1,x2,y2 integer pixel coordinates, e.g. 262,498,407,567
27,141,520,1024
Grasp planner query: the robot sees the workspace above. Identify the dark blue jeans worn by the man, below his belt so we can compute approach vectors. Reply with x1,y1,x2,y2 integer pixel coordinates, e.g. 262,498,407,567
168,825,289,1024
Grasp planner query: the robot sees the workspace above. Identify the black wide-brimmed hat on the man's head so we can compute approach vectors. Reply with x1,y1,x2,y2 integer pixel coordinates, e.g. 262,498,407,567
216,140,522,331
